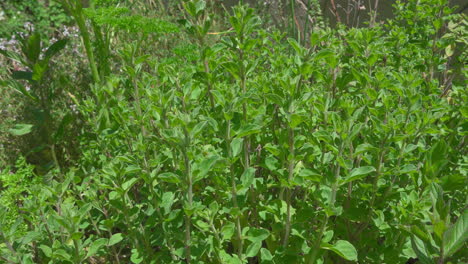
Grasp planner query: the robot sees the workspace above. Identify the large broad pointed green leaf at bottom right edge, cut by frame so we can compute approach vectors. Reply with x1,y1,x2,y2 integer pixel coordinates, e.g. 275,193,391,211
443,210,468,257
